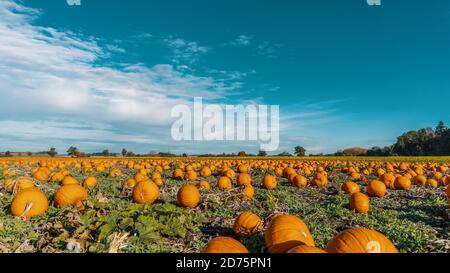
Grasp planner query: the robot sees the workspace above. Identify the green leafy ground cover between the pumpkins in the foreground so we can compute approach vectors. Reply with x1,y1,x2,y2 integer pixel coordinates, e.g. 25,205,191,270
0,163,450,253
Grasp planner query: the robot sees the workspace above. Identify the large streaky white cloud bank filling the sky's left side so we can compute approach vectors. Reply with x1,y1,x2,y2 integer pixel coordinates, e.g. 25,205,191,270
0,0,240,151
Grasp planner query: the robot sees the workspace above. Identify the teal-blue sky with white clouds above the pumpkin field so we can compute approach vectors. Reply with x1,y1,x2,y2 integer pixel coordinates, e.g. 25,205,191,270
0,0,450,153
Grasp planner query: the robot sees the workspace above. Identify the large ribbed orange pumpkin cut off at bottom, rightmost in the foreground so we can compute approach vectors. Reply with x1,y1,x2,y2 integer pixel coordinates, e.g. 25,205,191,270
325,228,398,253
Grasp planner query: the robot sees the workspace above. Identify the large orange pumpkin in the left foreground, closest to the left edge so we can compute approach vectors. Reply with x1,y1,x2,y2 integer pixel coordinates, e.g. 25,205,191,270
11,188,48,219
